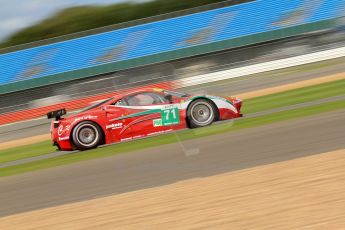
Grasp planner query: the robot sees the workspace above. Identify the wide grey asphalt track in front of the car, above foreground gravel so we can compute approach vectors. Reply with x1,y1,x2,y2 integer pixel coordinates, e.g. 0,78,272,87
0,110,345,216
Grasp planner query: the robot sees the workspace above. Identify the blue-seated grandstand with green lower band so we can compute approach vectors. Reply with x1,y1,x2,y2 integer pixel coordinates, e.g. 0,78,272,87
0,0,343,94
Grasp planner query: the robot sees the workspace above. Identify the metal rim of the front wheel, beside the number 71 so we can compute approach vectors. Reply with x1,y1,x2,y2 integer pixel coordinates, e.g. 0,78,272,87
191,102,213,125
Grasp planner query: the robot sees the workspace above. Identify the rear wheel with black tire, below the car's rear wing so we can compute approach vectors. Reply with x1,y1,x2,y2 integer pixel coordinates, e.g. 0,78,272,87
72,121,103,150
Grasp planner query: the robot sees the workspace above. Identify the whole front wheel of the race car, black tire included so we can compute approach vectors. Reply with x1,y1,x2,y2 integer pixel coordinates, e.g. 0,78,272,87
187,99,217,128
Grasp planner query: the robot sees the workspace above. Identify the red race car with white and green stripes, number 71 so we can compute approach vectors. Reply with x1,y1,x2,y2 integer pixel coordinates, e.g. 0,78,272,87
47,88,242,151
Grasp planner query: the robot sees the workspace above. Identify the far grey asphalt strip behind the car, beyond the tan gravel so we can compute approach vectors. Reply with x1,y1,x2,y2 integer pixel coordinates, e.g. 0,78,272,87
0,63,345,143
